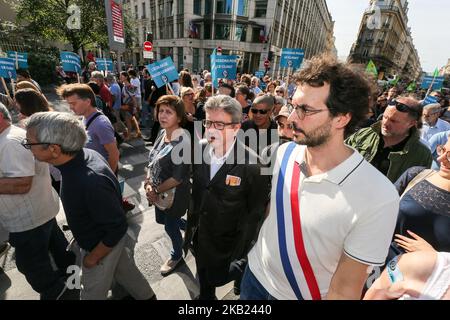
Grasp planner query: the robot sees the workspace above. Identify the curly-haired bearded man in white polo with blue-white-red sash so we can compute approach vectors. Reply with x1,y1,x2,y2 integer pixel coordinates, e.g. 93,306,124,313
241,57,399,300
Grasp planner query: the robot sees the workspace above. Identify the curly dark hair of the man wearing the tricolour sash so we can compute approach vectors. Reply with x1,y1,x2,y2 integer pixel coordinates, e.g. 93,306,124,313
294,55,373,137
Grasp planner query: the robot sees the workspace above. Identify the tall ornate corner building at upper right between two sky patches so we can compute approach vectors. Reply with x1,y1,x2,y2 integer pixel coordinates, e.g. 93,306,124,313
349,0,422,81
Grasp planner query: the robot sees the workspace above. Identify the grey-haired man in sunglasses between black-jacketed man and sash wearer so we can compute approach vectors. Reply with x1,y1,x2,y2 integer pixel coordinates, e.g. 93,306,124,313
242,95,278,155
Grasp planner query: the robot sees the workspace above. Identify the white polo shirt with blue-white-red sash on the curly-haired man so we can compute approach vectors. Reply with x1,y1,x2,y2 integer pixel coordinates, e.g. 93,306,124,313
248,143,399,300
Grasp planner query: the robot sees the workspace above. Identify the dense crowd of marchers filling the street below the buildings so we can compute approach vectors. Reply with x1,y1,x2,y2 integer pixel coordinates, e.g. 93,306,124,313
0,56,450,300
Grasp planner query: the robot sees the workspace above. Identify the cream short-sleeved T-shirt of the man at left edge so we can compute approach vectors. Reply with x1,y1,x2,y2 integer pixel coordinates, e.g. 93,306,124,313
0,126,59,232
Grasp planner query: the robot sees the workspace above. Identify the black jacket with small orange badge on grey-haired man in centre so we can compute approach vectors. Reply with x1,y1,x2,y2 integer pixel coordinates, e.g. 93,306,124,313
187,141,270,268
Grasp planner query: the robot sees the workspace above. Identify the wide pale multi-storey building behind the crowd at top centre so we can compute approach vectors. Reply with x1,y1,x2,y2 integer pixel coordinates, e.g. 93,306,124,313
124,0,334,72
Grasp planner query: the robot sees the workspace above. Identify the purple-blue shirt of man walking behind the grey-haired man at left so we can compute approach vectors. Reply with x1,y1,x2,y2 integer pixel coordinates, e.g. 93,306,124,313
84,112,116,160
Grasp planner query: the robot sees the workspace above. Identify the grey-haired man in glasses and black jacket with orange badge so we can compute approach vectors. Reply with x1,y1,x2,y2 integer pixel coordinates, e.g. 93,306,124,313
188,95,270,300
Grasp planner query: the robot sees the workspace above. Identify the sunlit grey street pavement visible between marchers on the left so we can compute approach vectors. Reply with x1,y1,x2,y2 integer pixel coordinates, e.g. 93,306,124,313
0,92,238,300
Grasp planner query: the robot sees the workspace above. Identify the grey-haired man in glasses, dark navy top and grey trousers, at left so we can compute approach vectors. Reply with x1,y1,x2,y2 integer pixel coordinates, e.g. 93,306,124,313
27,112,155,300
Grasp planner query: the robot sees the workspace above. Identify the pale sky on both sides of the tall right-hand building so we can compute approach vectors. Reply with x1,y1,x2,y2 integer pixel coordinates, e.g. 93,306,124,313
326,0,450,72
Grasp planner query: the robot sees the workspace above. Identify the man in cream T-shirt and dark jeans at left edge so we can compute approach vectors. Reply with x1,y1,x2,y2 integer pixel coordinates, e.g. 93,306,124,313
0,103,75,300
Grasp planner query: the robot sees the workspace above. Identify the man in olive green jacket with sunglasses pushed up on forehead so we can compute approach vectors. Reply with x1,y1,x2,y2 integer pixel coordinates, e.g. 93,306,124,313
347,97,432,182
